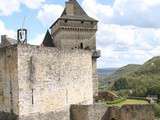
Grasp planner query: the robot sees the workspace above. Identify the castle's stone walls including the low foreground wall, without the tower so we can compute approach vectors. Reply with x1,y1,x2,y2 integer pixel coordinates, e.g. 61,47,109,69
0,45,154,120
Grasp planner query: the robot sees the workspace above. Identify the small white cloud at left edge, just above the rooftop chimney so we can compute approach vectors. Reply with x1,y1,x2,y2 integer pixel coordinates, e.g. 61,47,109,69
0,20,16,38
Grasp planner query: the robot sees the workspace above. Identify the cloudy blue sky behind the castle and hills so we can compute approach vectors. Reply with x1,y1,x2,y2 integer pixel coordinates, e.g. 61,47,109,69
0,0,160,68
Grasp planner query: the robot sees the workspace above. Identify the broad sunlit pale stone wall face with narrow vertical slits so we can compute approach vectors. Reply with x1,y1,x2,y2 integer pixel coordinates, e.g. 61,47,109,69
17,46,93,116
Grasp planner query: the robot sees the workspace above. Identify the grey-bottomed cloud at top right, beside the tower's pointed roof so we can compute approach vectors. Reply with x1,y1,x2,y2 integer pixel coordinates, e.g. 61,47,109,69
82,0,160,28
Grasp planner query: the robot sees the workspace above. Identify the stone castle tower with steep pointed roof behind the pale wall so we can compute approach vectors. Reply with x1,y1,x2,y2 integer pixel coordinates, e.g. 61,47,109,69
43,0,100,96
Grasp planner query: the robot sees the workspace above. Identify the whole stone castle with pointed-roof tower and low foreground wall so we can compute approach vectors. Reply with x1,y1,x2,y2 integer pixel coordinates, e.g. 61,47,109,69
0,0,154,120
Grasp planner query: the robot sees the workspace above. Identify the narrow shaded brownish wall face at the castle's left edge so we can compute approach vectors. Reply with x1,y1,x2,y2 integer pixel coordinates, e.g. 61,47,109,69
0,46,19,115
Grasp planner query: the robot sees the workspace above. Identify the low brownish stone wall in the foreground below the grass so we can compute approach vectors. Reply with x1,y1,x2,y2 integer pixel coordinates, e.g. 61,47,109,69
71,105,154,120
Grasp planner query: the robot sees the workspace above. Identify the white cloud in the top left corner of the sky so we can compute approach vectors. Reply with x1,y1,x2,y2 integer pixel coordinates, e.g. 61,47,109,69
0,0,45,16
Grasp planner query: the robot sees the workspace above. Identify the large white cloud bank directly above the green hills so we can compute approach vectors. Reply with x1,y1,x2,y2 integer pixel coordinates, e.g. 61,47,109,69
97,24,160,67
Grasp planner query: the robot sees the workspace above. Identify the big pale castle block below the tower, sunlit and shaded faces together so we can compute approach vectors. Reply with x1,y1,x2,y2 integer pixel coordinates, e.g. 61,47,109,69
0,45,93,120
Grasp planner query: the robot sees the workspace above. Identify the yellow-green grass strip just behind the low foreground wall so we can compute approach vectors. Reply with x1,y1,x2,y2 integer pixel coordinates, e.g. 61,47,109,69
108,99,149,107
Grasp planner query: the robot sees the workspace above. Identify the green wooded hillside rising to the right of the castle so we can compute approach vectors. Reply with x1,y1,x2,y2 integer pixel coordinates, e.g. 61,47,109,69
100,56,160,96
